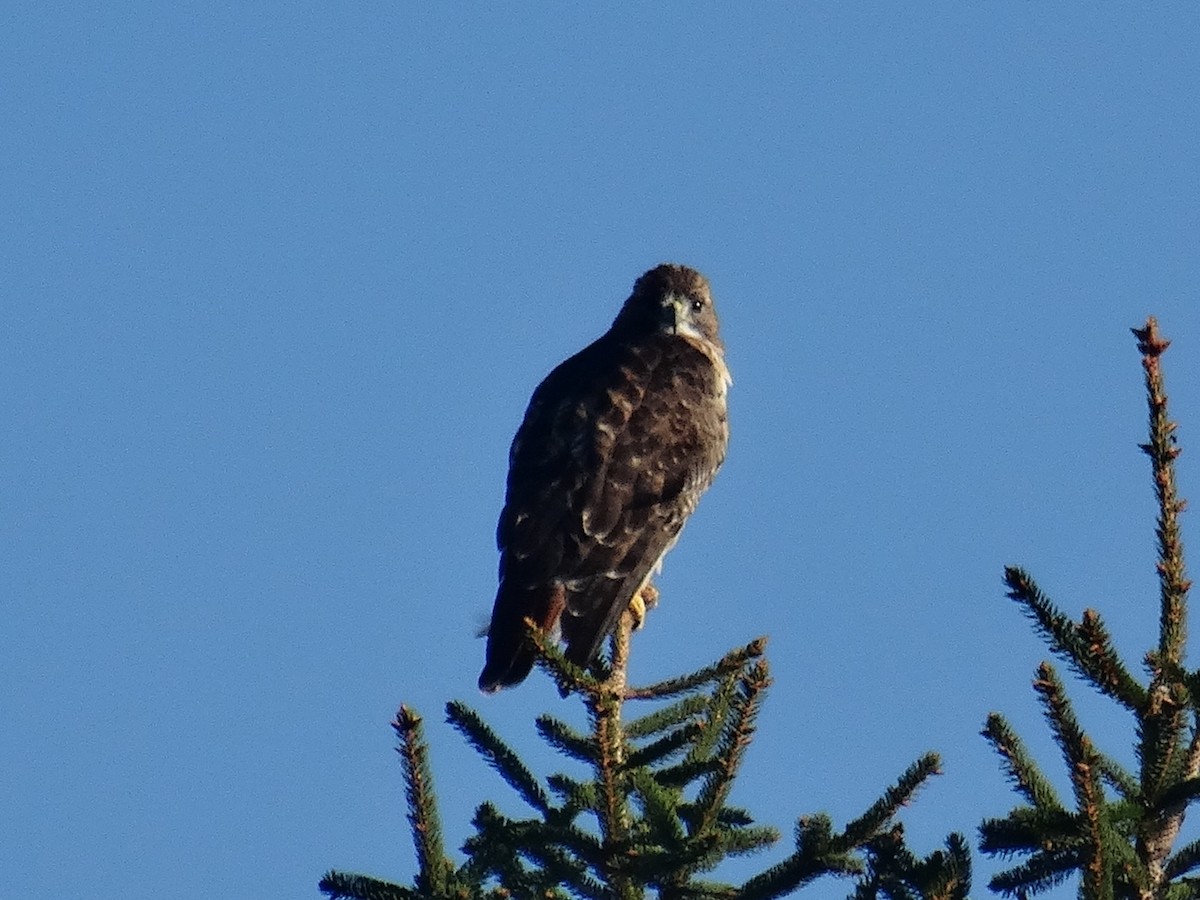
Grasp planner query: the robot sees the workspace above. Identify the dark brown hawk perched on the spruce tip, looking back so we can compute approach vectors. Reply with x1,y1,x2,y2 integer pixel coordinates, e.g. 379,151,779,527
479,265,730,692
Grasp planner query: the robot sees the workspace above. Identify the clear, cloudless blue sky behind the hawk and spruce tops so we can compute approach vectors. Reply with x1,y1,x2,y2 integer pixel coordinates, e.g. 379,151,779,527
0,2,1200,900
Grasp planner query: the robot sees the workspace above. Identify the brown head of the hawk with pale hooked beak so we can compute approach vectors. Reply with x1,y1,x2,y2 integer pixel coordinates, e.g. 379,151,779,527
612,263,724,352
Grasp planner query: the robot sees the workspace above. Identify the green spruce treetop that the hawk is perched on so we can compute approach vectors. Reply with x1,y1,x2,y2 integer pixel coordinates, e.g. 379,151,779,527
320,616,971,900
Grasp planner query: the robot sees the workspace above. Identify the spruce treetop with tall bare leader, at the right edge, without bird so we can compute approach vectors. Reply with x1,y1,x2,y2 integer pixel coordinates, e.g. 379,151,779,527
979,318,1200,900
